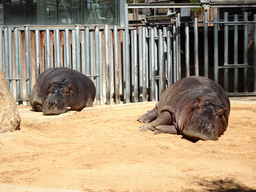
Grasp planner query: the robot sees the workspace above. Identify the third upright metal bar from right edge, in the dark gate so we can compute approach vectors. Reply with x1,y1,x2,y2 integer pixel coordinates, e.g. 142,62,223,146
234,14,238,92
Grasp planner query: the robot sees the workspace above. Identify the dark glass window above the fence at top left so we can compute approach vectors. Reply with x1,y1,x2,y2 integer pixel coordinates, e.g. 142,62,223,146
0,0,123,25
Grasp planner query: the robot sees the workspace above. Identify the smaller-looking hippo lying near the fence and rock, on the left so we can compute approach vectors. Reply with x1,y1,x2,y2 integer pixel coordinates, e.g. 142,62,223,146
30,67,96,115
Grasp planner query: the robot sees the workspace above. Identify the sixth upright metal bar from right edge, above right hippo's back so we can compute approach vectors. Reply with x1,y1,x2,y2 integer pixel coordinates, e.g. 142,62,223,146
204,11,209,77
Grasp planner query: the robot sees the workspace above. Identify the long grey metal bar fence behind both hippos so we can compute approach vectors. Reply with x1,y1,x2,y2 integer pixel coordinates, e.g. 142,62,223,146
0,3,256,104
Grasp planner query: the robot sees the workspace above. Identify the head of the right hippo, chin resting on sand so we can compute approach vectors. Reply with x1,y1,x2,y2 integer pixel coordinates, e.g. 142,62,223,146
183,97,228,140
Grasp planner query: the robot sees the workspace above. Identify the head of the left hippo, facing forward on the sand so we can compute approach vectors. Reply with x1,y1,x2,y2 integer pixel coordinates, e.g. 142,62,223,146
42,82,74,115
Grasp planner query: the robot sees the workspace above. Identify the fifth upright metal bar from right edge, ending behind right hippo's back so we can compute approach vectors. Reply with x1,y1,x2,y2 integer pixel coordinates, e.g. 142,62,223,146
214,15,219,83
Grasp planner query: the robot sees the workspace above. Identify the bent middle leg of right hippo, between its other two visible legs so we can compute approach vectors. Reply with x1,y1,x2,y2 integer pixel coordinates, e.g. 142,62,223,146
140,111,173,132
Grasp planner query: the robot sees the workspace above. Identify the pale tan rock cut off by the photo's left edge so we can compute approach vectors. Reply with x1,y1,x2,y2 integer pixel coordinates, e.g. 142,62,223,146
0,70,21,133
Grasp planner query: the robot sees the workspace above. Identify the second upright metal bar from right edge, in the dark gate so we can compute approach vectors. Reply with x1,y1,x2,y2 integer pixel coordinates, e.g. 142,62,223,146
244,12,248,92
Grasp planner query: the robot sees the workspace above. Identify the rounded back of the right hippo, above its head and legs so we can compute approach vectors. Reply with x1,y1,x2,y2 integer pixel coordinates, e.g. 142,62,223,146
158,76,230,116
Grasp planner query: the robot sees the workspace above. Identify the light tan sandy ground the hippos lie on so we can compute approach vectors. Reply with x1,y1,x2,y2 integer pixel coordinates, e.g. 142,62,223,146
0,98,256,192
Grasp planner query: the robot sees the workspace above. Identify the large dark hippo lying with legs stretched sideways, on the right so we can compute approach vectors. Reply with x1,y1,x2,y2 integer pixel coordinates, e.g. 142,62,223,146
138,76,230,140
